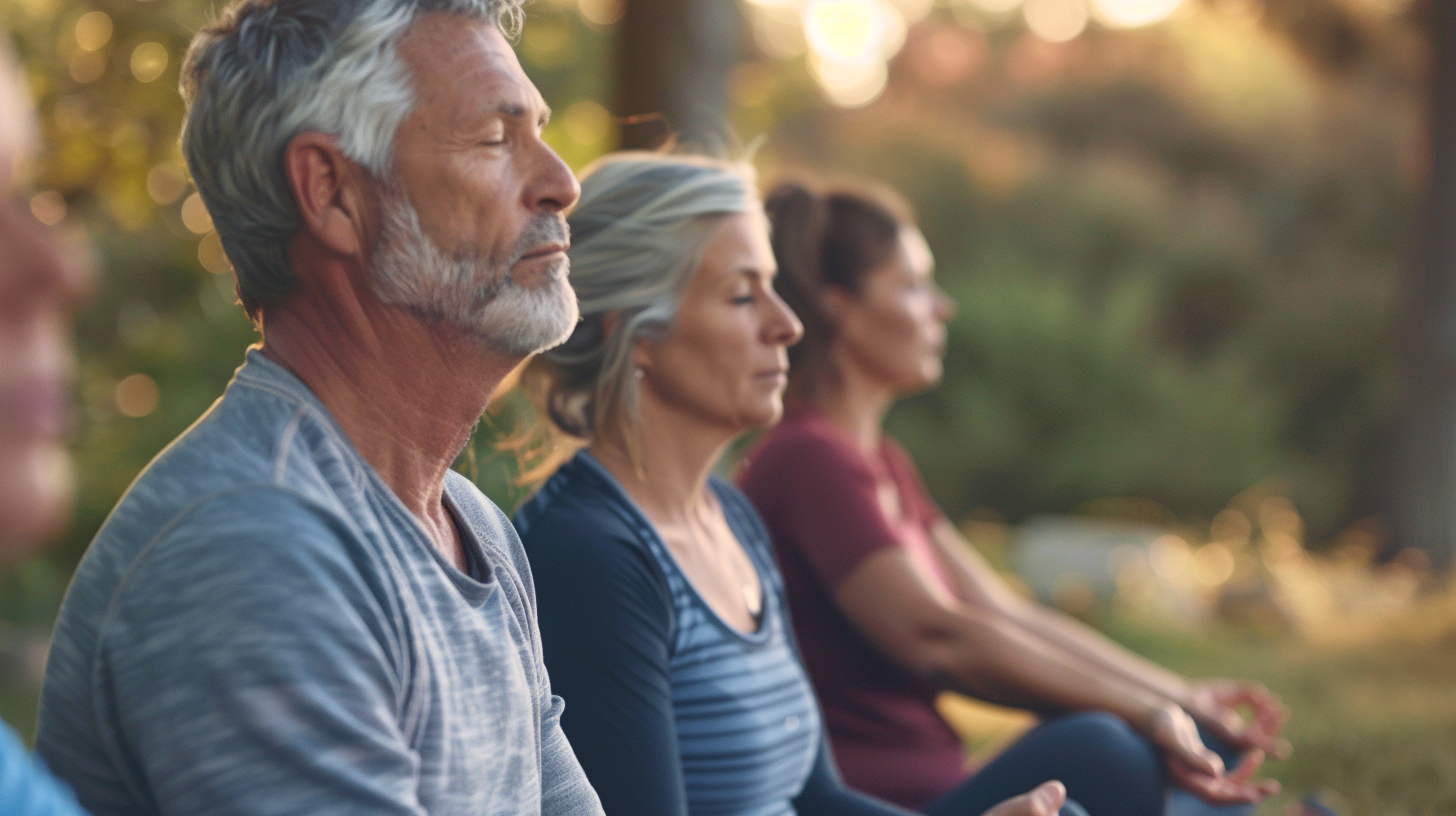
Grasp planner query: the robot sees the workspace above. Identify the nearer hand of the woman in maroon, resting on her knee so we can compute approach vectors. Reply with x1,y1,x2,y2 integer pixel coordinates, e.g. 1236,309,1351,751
1147,704,1278,804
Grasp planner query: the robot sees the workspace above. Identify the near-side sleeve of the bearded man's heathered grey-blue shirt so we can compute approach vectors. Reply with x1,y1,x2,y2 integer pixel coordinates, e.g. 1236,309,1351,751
96,488,424,816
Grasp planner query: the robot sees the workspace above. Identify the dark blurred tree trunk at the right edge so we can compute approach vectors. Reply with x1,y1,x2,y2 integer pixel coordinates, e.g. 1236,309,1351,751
1379,0,1456,564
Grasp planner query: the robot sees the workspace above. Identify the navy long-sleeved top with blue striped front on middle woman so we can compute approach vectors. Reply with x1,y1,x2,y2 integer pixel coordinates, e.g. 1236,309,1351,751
515,452,904,816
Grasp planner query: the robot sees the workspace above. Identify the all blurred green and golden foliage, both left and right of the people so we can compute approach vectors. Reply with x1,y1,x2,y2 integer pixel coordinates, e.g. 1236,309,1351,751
0,0,1424,612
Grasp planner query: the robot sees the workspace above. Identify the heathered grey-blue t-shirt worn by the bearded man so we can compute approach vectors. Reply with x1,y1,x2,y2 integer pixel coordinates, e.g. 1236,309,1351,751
36,350,601,816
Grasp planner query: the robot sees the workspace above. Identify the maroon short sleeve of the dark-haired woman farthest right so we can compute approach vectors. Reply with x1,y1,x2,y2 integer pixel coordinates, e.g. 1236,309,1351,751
740,425,900,590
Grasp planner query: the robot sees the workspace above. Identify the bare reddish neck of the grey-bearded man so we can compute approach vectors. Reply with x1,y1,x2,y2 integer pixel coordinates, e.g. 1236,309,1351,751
262,284,520,565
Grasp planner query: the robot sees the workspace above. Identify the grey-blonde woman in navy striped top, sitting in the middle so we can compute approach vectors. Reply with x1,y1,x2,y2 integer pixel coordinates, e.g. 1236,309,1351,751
515,153,1083,816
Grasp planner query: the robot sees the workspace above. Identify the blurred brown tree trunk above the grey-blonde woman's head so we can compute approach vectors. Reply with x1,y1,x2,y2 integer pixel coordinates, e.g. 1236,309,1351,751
617,0,740,152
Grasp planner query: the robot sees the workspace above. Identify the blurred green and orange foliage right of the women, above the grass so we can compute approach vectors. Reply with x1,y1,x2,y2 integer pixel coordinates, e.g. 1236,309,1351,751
741,9,1425,541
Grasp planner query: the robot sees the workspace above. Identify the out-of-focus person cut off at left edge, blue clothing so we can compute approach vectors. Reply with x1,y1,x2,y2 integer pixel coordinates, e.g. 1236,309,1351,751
0,29,84,816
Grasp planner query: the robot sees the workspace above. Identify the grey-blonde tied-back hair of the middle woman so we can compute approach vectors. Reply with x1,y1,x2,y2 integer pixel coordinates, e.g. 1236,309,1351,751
527,152,759,466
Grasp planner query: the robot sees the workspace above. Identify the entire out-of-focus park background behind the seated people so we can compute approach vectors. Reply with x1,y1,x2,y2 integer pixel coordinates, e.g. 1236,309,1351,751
0,0,1456,815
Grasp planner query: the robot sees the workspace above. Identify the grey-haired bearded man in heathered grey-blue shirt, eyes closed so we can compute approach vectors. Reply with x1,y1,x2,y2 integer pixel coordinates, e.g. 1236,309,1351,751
36,0,601,816
